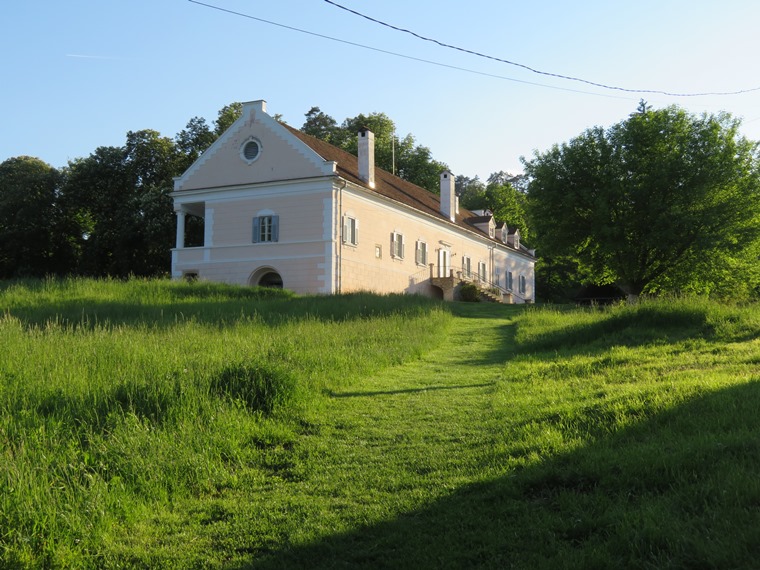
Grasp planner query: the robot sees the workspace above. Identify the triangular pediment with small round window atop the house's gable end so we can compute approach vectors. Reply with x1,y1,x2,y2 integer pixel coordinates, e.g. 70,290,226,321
174,101,335,192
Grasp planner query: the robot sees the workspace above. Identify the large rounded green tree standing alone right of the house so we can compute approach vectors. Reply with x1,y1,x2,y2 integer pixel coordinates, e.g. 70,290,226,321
524,103,760,296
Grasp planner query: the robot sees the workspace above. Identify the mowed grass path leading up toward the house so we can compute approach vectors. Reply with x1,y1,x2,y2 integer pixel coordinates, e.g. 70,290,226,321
181,305,521,568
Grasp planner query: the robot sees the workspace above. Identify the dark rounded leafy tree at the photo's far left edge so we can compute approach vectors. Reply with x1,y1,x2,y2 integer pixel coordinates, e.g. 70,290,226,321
0,156,74,278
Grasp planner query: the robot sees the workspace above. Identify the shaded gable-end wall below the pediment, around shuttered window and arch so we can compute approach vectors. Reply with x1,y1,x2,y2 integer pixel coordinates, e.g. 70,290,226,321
177,179,335,293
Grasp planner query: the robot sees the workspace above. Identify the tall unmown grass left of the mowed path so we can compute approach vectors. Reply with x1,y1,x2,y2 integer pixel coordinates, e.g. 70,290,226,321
0,279,450,568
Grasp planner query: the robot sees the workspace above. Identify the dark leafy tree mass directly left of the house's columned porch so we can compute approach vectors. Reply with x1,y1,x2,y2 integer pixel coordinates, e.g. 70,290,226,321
63,130,181,276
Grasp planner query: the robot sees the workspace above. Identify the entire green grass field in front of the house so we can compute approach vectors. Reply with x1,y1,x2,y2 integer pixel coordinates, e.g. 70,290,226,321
0,280,760,569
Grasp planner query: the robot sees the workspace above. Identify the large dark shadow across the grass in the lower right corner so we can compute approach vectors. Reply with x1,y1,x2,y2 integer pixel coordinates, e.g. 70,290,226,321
229,382,760,569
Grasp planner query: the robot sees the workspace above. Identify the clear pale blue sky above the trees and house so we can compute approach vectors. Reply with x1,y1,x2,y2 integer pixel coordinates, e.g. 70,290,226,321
0,0,760,178
